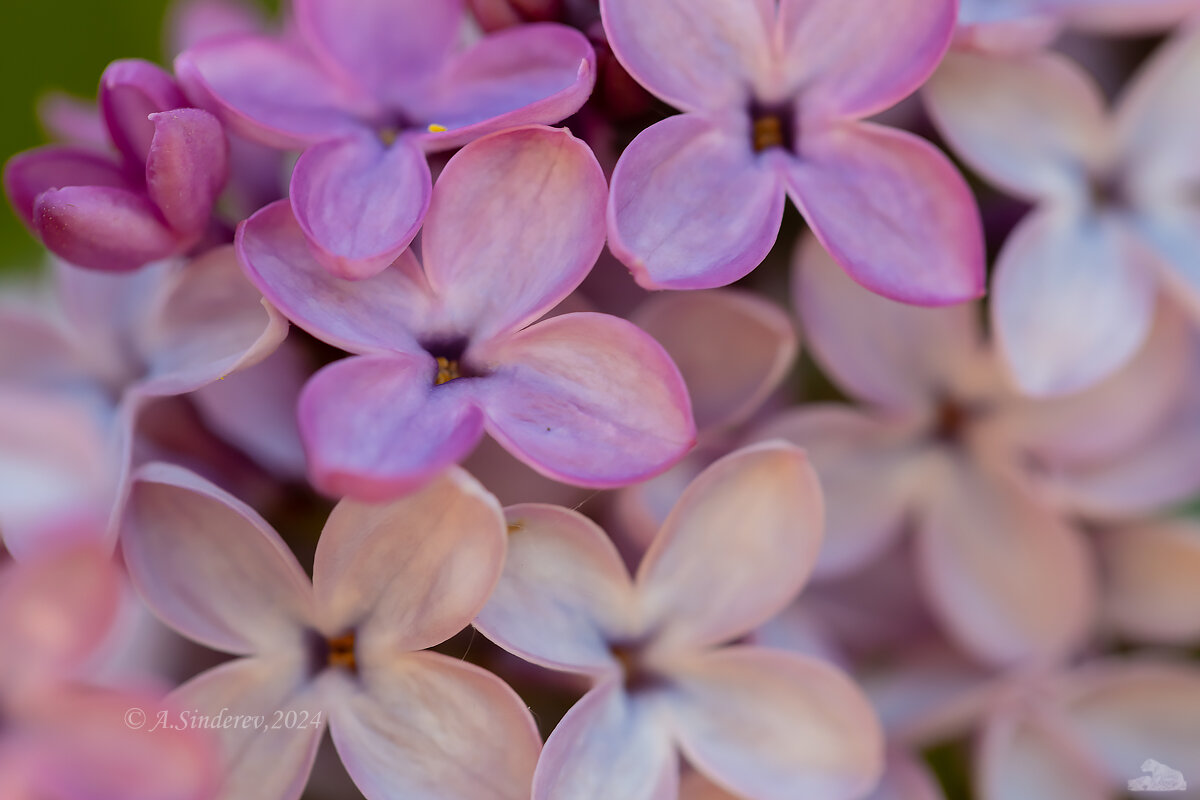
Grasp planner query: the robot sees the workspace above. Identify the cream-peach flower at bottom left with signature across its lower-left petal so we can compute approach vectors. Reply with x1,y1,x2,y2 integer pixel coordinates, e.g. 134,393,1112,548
121,464,540,800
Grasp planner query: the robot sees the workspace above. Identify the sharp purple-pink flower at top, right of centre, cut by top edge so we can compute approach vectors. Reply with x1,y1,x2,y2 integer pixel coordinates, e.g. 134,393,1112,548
601,0,984,305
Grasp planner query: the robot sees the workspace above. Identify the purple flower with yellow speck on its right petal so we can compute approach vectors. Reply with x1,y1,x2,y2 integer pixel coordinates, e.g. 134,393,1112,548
175,0,595,278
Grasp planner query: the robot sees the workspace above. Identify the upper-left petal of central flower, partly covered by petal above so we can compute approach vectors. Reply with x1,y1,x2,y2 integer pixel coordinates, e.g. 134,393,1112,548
236,200,430,353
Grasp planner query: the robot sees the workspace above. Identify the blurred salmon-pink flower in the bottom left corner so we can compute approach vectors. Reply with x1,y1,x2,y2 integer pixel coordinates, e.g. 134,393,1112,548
0,537,216,800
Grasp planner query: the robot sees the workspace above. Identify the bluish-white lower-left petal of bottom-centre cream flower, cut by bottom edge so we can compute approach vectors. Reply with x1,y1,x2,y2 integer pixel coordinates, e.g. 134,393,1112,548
533,681,679,800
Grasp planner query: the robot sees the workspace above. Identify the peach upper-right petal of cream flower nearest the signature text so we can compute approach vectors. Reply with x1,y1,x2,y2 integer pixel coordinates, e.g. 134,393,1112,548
313,468,505,661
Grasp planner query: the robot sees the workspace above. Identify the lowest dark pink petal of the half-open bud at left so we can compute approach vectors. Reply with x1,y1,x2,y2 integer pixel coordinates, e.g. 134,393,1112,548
34,186,180,272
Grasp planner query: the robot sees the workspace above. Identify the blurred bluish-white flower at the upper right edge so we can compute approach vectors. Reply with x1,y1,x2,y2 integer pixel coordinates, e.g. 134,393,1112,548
925,28,1200,395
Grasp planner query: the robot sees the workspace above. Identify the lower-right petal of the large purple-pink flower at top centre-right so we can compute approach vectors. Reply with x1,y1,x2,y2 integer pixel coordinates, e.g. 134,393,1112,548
786,122,984,306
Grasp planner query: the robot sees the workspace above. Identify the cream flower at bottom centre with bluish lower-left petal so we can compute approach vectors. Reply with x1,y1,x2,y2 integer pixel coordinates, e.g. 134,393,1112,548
475,444,882,800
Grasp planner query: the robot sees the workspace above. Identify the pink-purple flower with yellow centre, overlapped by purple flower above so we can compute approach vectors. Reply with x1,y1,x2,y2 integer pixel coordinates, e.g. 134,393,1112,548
239,127,695,500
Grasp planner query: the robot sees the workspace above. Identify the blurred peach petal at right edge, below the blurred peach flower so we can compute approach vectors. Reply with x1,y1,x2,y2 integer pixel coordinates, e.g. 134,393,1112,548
1098,519,1200,645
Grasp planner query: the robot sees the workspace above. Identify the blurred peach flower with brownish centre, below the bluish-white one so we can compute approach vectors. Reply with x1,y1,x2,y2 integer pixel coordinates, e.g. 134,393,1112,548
756,239,1194,664
